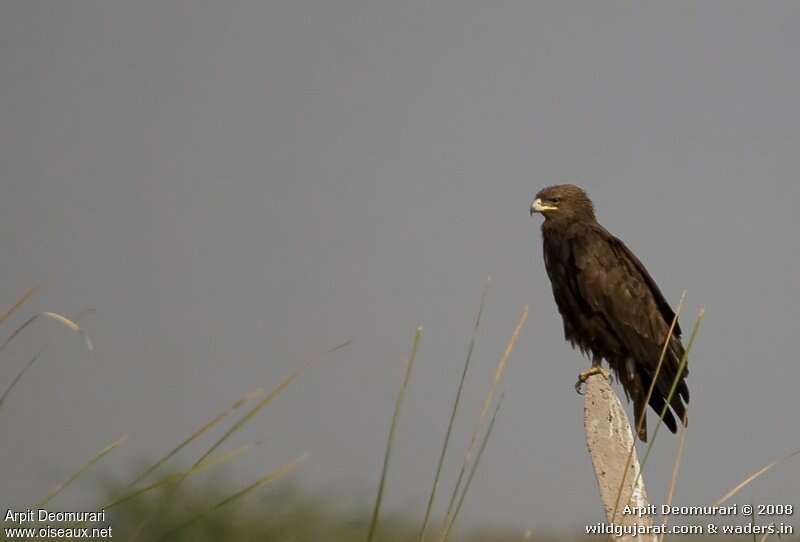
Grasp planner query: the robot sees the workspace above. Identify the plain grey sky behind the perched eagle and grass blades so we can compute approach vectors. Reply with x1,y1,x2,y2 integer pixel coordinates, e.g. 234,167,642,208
0,0,800,529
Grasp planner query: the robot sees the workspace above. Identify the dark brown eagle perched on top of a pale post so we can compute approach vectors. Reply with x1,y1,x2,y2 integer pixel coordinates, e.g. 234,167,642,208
530,184,689,442
